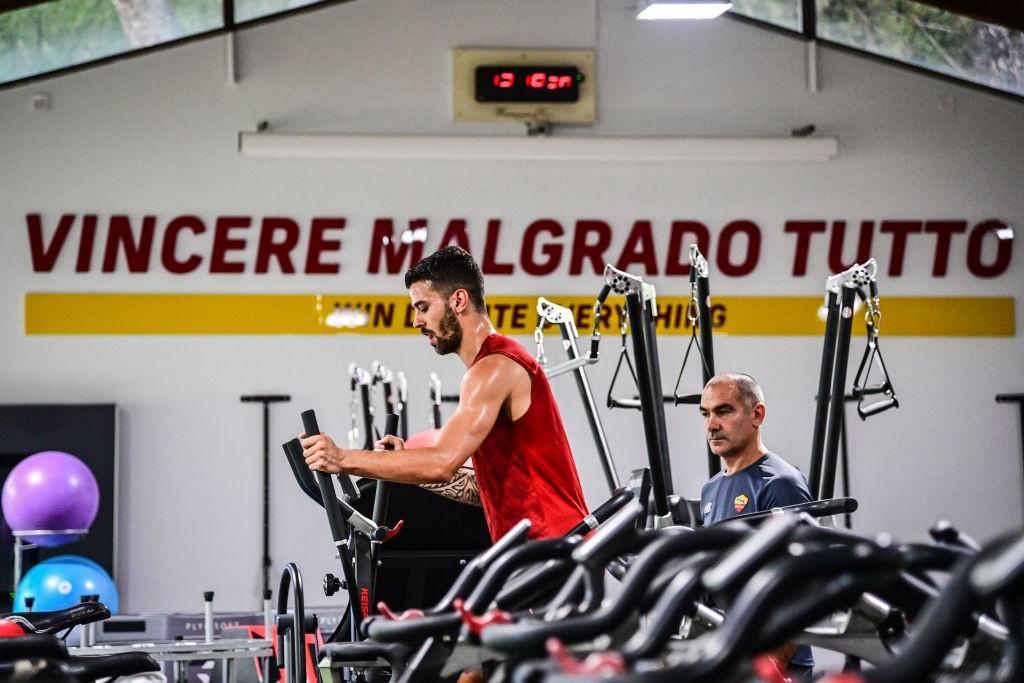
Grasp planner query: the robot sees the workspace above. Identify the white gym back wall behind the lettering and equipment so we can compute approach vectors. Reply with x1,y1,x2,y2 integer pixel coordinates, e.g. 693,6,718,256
0,0,1024,611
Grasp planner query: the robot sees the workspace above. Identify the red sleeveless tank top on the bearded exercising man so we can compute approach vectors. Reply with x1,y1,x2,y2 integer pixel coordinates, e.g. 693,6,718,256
470,334,587,540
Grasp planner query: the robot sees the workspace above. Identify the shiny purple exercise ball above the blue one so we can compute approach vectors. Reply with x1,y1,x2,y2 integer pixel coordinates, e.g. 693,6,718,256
0,451,99,548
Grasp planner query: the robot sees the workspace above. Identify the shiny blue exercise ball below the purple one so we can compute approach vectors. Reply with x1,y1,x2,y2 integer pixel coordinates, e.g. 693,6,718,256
14,556,119,614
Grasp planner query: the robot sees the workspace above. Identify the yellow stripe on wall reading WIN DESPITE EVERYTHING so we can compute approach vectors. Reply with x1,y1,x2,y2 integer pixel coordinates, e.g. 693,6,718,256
25,292,1016,337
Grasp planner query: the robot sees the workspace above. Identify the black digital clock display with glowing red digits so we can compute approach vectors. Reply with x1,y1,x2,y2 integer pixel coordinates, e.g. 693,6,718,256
475,65,584,102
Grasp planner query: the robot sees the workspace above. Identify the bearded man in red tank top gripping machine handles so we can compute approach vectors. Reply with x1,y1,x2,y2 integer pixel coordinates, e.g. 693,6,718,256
302,247,587,539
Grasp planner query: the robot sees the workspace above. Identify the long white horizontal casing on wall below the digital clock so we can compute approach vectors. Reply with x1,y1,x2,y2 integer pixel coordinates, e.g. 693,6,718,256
239,132,839,164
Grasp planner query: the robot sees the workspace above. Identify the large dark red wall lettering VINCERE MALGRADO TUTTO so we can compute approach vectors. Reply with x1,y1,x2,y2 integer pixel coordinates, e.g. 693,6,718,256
26,213,1013,278
